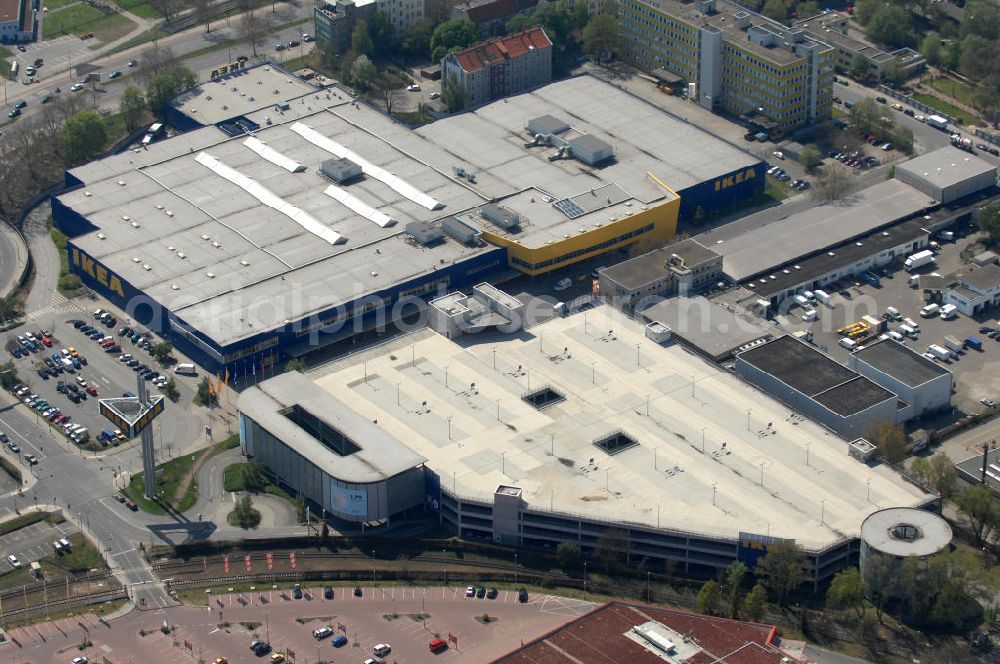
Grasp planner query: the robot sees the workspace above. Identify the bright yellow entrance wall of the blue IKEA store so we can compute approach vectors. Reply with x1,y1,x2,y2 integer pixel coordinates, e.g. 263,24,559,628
483,195,681,276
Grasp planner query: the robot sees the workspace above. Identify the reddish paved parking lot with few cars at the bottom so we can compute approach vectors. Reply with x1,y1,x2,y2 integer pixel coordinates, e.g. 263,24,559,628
0,585,594,664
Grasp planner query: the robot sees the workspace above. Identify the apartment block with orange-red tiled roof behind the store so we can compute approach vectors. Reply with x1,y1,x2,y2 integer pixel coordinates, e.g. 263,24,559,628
441,27,552,108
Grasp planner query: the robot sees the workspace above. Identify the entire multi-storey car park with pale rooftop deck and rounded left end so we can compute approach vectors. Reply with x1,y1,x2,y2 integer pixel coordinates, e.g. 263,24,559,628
237,306,932,579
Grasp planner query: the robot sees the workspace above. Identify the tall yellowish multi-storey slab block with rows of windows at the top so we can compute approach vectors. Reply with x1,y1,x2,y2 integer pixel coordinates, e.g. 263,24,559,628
618,0,835,131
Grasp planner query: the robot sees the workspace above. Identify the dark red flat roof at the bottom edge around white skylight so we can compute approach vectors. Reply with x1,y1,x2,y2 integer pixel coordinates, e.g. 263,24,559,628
495,602,796,664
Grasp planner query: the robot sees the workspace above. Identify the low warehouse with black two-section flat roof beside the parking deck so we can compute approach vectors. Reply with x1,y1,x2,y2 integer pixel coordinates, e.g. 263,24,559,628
736,336,909,440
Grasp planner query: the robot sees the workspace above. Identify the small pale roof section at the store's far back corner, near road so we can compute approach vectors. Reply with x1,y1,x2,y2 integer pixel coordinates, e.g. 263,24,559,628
171,64,316,125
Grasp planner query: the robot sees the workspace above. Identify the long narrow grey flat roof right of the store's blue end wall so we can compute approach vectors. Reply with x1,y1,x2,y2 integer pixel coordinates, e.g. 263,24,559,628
695,180,931,281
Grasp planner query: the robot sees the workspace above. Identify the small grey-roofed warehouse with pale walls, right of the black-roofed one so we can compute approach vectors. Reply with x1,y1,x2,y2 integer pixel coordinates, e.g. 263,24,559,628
847,339,954,420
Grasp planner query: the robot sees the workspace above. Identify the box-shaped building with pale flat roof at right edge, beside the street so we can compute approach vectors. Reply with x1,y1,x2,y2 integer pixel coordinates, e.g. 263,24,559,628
896,146,997,204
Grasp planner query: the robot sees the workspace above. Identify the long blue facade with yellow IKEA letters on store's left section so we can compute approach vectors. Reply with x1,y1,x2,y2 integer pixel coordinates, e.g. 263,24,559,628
52,192,507,384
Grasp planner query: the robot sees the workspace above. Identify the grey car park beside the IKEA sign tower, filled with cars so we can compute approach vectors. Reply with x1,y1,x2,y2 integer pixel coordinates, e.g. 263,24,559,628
5,312,200,463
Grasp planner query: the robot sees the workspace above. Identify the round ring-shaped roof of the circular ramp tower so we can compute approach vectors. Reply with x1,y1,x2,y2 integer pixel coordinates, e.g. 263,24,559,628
861,507,952,557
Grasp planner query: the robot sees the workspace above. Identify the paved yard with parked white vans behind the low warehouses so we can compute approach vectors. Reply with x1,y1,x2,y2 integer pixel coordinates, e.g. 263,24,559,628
781,220,1000,413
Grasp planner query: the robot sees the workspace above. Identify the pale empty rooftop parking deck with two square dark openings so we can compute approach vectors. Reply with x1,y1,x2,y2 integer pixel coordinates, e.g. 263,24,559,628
306,305,929,549
